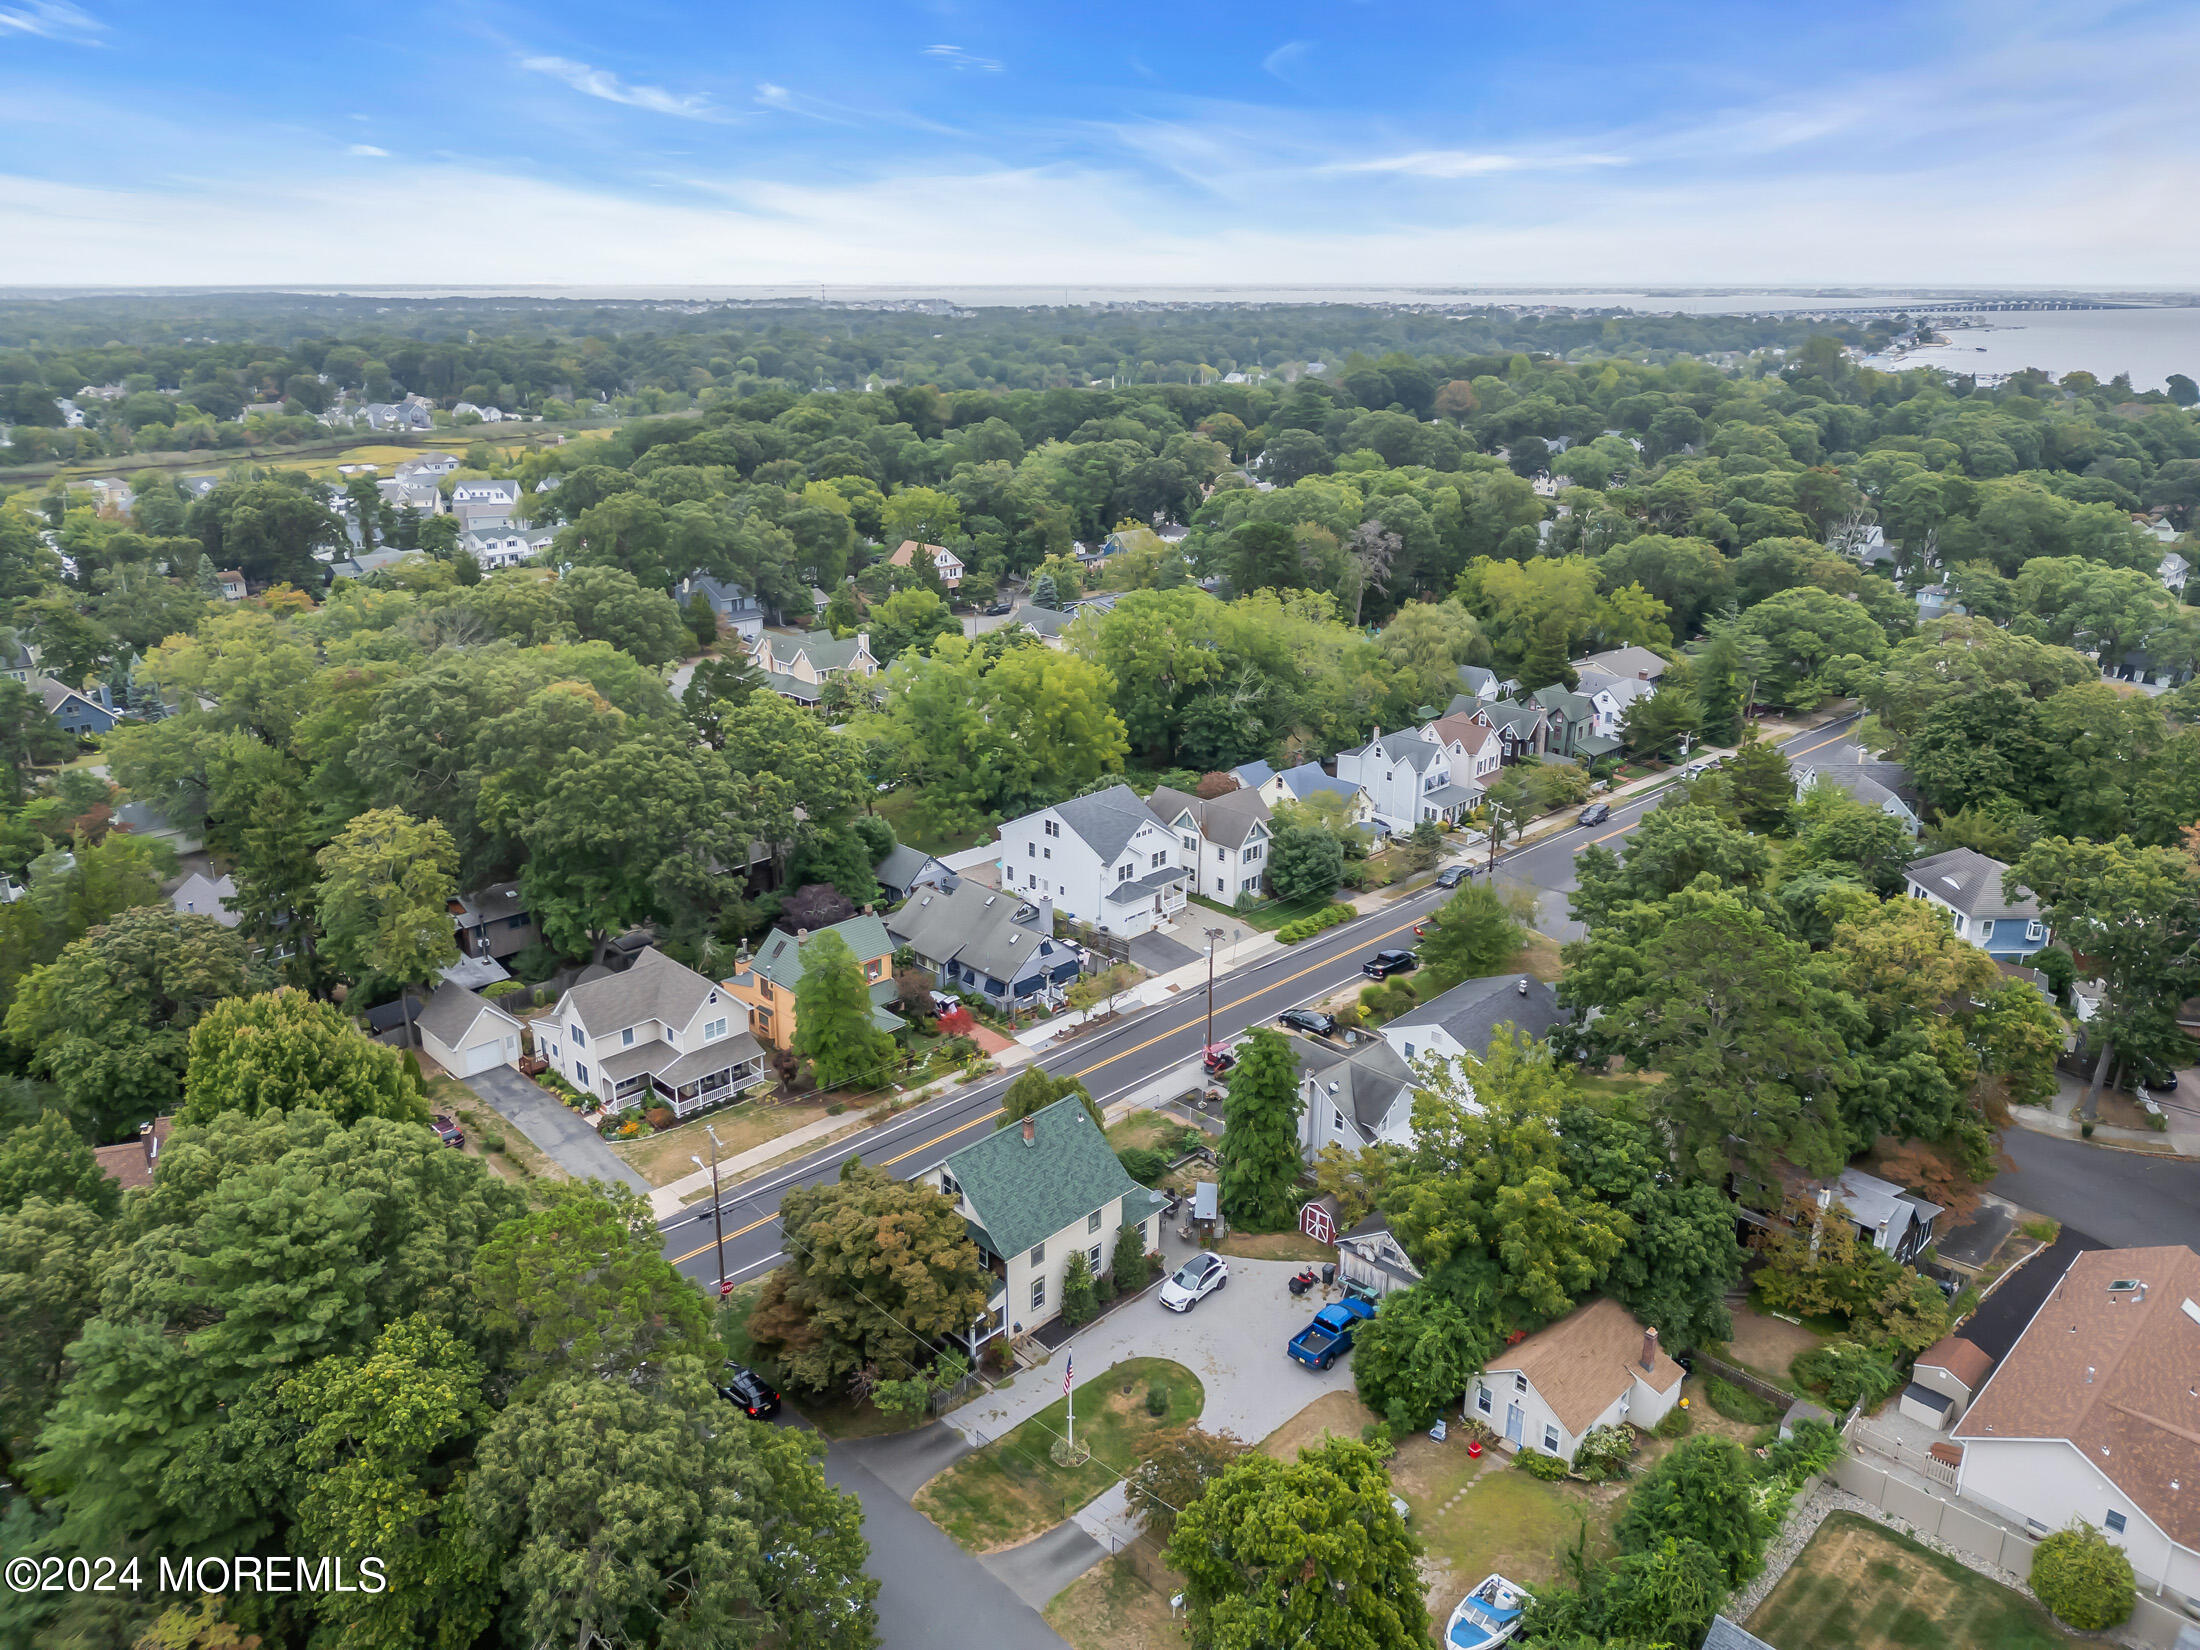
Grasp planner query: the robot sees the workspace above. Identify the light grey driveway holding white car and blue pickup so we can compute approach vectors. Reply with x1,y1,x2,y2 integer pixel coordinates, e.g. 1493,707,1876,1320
946,1236,1353,1443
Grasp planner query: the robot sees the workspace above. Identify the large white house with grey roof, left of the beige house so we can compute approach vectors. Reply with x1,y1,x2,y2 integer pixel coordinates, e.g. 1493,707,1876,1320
997,785,1192,935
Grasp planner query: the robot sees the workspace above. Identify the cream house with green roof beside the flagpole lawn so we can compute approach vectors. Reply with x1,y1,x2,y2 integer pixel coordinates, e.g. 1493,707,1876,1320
915,1096,1162,1375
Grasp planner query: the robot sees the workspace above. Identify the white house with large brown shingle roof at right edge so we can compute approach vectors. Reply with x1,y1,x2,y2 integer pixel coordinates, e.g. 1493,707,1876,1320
1951,1245,2200,1608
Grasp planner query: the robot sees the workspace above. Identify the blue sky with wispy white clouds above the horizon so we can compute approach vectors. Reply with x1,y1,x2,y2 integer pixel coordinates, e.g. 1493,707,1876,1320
0,0,2200,286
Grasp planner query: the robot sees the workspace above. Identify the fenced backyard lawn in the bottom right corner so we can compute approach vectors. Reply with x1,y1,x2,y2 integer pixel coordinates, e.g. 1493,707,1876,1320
1749,1511,2086,1650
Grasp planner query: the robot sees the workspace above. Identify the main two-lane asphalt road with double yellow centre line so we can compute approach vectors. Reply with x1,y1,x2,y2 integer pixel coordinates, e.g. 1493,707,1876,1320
658,704,1852,1283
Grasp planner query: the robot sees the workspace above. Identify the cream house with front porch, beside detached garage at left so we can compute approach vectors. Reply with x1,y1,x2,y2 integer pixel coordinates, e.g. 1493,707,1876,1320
535,946,770,1118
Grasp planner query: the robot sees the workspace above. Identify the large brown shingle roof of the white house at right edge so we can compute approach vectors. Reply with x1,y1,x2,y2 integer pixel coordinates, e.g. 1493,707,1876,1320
1956,1245,2200,1547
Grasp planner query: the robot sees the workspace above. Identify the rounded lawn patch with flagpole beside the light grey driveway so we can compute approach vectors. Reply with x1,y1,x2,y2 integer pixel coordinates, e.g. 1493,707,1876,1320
915,1357,1206,1553
